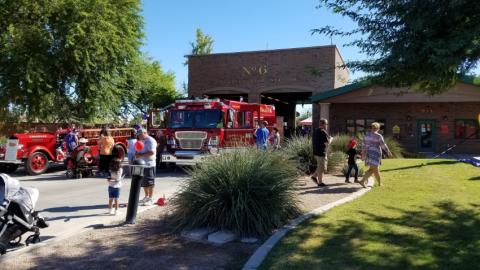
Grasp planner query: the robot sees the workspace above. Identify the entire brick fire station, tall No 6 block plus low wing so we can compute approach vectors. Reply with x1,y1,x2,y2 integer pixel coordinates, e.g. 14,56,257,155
188,45,480,153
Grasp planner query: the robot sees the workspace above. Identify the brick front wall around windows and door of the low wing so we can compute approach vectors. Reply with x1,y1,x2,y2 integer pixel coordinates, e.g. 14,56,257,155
330,102,480,154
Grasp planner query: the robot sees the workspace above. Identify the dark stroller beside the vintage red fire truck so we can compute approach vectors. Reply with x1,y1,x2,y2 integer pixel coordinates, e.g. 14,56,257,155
65,138,96,178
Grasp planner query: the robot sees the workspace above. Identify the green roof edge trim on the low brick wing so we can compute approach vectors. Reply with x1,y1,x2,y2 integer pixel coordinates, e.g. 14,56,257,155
310,76,480,103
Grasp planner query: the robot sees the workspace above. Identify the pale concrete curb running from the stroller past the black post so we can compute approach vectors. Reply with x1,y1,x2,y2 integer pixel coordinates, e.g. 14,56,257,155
0,204,158,261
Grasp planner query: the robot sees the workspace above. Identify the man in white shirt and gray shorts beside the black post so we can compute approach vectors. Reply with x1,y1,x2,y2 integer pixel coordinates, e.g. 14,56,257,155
135,129,157,205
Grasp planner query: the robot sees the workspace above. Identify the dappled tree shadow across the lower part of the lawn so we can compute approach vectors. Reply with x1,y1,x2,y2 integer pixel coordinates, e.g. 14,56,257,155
274,201,480,269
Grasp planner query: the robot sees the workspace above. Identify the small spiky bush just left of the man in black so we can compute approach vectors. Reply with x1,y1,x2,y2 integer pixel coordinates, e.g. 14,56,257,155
281,136,316,173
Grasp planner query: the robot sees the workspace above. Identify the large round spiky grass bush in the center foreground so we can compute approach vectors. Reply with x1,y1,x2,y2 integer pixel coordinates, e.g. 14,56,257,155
172,149,300,236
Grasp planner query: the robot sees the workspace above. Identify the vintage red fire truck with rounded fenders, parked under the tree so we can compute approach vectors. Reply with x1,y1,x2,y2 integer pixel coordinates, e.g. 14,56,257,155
0,128,131,175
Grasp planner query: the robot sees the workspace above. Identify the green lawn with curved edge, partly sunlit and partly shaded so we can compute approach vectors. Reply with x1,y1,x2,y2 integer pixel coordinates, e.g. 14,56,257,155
261,159,480,270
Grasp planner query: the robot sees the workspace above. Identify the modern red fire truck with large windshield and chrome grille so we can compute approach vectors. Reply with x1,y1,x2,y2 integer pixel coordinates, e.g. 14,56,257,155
148,99,276,165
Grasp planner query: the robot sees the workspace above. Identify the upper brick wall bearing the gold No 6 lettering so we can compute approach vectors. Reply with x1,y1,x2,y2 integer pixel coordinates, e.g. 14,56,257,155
188,46,348,96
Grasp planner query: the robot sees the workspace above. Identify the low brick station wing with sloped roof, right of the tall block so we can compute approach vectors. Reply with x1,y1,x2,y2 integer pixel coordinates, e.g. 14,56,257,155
312,78,480,154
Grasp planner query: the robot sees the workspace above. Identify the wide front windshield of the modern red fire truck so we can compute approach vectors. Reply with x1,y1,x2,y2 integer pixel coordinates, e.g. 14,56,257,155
169,110,223,128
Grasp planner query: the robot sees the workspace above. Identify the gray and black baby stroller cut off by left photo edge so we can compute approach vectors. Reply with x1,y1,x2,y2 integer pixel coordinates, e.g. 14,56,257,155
0,173,48,255
